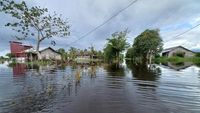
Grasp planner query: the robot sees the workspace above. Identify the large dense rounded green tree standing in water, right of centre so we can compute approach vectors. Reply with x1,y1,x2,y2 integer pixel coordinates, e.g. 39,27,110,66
133,29,163,63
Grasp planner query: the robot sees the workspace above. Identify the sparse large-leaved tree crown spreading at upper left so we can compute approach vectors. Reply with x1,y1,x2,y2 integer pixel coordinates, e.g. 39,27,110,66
0,0,70,52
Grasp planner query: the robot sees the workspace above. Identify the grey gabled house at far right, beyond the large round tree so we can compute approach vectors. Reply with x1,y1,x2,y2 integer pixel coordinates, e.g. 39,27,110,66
161,46,195,57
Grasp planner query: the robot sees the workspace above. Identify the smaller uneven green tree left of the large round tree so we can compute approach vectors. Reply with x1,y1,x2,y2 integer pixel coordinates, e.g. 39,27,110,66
104,30,129,61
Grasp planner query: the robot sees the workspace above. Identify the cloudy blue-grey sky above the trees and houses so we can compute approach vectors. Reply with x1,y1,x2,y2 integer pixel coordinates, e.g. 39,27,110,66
0,0,200,56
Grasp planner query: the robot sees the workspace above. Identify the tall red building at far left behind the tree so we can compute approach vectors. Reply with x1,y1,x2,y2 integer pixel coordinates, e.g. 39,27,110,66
10,41,33,61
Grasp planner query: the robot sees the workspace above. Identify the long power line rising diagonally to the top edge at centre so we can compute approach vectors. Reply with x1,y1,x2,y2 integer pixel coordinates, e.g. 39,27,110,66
67,0,138,46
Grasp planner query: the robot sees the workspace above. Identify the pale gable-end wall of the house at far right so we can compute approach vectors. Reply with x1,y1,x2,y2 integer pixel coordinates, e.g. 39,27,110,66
168,47,195,57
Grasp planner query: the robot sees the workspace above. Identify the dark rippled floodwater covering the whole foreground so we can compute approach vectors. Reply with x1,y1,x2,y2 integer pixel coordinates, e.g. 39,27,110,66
0,63,200,113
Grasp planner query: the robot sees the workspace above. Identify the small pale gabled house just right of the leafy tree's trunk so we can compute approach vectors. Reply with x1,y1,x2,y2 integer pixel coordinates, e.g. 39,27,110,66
38,47,61,60
